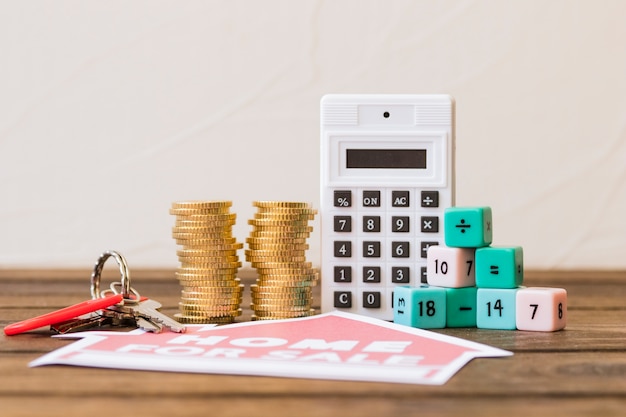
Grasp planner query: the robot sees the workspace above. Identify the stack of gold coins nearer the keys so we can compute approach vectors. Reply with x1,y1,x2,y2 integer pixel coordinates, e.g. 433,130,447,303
170,201,243,324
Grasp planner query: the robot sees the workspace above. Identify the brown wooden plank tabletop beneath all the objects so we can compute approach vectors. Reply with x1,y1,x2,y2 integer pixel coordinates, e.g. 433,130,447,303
0,270,626,417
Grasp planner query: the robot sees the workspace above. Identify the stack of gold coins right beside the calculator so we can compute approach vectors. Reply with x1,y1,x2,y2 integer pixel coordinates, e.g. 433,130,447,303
245,201,319,320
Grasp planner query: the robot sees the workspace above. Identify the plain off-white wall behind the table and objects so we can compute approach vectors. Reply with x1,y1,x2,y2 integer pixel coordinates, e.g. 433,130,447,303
0,0,626,269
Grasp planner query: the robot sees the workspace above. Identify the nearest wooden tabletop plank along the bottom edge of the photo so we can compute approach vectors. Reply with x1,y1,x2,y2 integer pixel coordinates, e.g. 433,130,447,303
0,389,626,417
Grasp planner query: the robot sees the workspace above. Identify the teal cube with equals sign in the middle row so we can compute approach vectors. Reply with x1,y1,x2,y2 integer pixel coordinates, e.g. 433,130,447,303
475,246,524,288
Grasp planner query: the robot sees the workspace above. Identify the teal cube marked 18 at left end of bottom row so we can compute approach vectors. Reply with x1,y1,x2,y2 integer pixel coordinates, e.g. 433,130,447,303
393,285,446,329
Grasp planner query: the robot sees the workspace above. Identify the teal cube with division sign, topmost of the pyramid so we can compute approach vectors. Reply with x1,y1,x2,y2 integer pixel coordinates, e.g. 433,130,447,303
444,207,493,248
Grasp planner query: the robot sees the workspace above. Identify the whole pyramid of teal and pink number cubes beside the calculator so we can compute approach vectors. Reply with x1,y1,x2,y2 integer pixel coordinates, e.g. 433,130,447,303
393,207,567,331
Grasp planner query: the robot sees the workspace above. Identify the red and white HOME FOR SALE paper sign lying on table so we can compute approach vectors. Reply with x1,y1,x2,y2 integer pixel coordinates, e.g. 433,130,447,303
30,312,512,385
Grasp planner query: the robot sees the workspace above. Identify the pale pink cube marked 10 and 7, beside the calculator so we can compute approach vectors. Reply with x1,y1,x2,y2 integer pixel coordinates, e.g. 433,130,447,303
426,245,476,288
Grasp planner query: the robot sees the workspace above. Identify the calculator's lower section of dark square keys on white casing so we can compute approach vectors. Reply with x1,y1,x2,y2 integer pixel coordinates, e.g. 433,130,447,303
322,187,444,320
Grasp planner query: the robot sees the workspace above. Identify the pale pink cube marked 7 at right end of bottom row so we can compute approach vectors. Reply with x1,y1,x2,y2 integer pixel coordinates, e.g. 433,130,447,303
515,287,567,332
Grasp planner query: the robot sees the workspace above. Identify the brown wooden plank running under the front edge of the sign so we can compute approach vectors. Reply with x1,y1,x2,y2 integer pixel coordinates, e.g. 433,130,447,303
0,352,626,399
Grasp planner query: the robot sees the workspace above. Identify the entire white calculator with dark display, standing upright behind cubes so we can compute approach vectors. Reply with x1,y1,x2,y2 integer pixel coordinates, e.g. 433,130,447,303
320,94,455,320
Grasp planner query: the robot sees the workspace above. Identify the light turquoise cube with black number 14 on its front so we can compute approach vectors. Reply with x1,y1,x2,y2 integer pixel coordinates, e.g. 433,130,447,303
476,288,518,330
